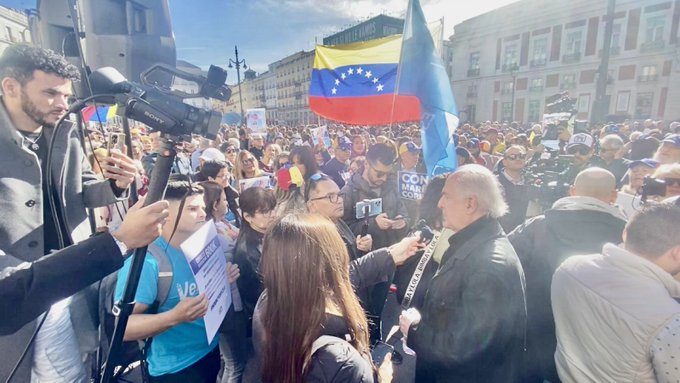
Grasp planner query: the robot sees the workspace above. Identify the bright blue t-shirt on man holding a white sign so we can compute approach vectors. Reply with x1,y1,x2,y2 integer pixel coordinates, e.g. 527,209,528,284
114,237,219,376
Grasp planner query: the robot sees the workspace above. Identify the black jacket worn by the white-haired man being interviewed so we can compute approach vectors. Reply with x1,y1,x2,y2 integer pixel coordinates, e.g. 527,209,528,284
408,217,526,383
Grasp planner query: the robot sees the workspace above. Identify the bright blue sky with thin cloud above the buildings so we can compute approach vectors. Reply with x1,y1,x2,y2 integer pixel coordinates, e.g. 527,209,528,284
0,0,514,83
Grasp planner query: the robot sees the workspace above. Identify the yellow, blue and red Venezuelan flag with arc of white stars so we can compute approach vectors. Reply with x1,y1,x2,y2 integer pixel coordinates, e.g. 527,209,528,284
309,35,420,125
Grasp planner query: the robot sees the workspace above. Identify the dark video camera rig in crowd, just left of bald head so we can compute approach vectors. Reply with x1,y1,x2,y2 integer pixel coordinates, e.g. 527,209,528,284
524,147,571,209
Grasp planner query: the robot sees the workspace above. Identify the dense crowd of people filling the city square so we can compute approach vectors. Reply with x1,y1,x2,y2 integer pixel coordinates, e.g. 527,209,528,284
0,45,680,383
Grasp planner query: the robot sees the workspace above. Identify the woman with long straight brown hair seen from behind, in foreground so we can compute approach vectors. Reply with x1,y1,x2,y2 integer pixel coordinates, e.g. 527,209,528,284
258,214,392,383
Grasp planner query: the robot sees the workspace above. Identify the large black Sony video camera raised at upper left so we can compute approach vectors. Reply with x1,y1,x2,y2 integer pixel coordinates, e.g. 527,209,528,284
89,64,231,139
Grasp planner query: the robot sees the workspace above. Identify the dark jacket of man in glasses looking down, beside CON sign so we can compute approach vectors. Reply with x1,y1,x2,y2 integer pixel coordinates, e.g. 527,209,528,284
342,168,408,249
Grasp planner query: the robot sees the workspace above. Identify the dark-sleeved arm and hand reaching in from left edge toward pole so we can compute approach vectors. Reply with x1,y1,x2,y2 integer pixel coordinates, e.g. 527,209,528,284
0,201,168,382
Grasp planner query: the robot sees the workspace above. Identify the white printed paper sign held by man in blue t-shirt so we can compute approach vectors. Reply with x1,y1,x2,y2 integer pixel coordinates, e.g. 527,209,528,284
180,220,231,344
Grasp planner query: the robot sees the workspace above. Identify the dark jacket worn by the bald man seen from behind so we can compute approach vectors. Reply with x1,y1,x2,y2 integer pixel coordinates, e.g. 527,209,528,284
508,209,626,382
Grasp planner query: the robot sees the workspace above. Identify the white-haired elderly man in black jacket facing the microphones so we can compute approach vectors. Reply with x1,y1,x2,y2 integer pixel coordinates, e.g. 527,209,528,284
399,165,527,382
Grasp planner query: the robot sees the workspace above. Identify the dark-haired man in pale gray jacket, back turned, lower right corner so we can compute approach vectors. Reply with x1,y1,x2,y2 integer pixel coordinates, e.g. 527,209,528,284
551,203,680,383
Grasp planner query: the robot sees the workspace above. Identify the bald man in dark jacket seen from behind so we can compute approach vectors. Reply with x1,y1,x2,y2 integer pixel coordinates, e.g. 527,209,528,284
508,168,626,382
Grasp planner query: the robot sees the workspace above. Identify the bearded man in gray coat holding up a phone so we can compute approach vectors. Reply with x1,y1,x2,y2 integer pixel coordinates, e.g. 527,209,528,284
0,45,135,382
